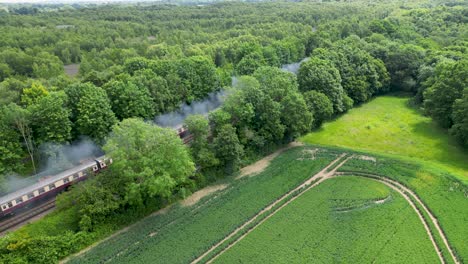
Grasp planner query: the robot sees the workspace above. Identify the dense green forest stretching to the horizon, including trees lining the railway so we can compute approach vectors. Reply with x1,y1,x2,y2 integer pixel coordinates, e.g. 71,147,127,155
0,1,468,263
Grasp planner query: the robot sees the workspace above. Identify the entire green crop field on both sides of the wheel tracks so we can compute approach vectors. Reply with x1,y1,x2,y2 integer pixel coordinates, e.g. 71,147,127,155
70,146,468,263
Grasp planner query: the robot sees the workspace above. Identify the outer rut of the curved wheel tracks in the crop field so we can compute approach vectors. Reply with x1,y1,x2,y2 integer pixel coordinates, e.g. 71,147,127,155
336,172,461,264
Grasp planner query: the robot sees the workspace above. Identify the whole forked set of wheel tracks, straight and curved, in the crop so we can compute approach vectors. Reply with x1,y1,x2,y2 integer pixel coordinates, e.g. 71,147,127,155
195,158,461,264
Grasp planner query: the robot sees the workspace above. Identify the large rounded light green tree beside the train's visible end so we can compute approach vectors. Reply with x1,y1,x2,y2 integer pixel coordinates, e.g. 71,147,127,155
104,119,195,205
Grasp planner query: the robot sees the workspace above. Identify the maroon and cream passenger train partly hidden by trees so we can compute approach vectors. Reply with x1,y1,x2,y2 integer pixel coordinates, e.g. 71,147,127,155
0,126,192,219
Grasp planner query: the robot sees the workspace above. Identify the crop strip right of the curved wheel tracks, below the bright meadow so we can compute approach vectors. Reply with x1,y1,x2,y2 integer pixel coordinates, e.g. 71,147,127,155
340,156,468,260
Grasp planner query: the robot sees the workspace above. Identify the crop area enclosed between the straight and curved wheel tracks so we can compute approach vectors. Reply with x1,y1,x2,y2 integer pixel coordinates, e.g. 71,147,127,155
214,177,438,263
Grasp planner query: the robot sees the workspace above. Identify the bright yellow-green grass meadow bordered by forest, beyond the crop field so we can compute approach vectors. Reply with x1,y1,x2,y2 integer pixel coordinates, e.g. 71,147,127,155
301,96,468,182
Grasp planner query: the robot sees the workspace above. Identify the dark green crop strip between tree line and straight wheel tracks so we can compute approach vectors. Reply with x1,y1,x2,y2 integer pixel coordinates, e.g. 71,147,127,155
70,147,339,263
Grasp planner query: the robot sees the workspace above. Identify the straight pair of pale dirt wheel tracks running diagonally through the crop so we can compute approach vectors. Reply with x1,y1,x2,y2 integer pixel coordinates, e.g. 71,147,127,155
191,153,351,264
